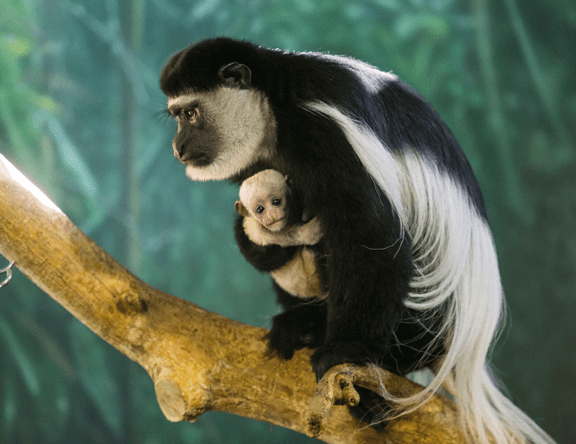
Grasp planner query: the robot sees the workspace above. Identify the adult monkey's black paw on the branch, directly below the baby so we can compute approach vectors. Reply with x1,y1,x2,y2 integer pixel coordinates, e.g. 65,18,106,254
267,303,326,359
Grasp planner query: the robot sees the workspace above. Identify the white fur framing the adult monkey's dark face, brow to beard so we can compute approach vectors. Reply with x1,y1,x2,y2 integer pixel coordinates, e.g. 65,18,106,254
168,87,276,181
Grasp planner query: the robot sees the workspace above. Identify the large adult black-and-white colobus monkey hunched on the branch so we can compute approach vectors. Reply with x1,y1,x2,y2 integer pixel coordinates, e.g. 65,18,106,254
160,38,553,444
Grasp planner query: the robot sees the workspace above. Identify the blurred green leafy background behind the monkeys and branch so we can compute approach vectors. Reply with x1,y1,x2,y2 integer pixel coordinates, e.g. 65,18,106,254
0,0,576,444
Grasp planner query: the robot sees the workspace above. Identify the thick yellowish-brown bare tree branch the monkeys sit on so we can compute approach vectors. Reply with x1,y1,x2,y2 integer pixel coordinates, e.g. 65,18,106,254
0,155,464,444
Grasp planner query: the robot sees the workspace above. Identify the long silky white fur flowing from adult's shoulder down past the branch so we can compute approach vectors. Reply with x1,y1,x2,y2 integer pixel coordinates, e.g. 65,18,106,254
307,103,554,444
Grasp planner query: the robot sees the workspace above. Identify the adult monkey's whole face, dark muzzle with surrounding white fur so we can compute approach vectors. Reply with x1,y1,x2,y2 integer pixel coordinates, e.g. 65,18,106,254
168,86,276,181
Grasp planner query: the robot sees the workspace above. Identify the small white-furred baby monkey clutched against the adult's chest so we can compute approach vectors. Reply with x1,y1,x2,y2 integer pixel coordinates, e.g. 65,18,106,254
234,170,324,298
